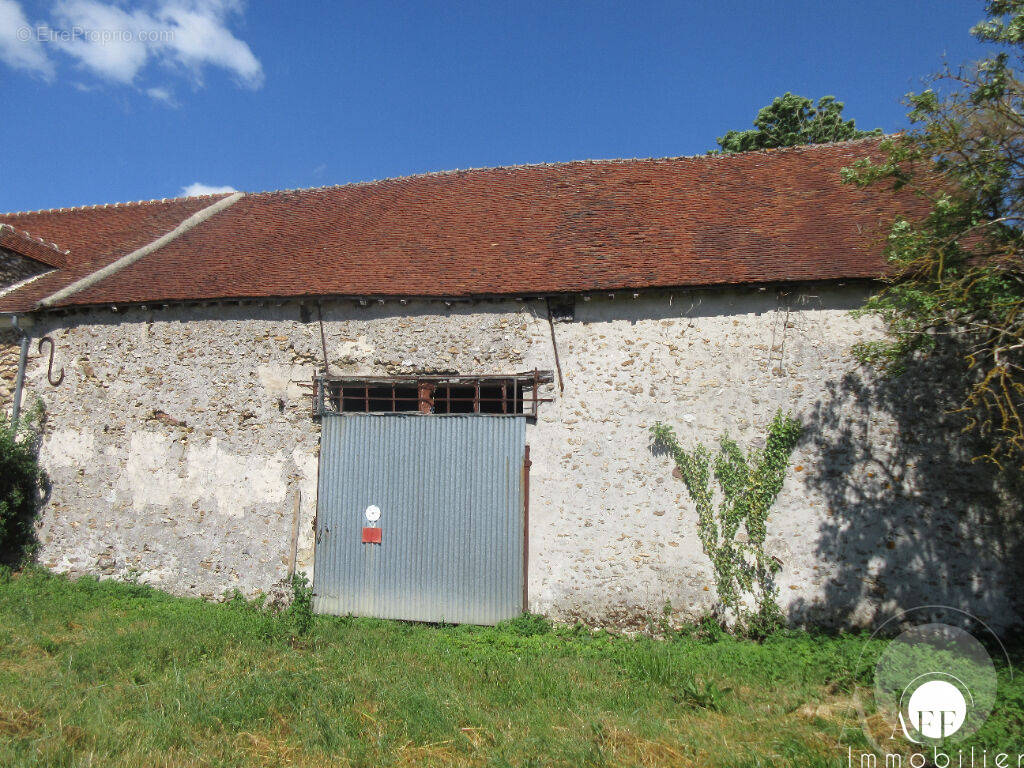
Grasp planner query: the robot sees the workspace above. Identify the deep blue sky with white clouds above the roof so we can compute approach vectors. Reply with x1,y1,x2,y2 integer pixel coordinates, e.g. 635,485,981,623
0,0,983,211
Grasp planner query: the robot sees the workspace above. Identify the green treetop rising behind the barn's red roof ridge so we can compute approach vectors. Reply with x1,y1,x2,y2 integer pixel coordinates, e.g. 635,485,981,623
717,91,882,153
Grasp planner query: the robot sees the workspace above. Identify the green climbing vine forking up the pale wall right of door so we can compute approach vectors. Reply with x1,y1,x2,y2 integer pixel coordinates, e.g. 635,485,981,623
650,411,802,629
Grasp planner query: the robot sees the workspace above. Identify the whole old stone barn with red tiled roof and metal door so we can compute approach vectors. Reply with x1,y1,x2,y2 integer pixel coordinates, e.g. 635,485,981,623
0,140,1022,626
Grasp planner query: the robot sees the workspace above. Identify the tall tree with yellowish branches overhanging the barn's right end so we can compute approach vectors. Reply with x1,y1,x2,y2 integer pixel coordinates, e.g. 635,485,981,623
844,0,1024,468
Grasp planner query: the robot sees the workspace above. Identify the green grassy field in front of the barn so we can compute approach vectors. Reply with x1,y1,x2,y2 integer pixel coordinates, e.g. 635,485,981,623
0,571,1024,768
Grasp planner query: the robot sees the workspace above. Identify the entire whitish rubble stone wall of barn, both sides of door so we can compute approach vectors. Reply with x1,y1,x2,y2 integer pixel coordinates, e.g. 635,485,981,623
18,289,1022,626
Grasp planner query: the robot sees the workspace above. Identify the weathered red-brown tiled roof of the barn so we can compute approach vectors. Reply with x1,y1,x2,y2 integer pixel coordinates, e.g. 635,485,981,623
0,140,921,311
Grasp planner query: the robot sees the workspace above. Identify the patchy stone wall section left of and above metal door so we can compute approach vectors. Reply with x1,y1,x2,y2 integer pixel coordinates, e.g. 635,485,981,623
25,302,541,597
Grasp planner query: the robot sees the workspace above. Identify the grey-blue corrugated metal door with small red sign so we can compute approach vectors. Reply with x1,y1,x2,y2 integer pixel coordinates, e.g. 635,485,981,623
313,414,526,624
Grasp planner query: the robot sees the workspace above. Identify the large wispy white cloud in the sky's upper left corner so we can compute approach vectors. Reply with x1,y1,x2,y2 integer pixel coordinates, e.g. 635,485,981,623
0,0,263,93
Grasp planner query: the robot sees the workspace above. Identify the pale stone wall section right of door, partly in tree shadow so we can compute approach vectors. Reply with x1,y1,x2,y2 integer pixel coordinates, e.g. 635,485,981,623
530,288,1024,626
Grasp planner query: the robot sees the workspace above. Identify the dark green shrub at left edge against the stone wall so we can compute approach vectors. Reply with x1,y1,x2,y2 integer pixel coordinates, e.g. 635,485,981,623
0,400,48,565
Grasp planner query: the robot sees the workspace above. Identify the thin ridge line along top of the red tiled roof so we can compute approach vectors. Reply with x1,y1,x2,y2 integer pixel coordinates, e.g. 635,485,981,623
0,134,894,219
